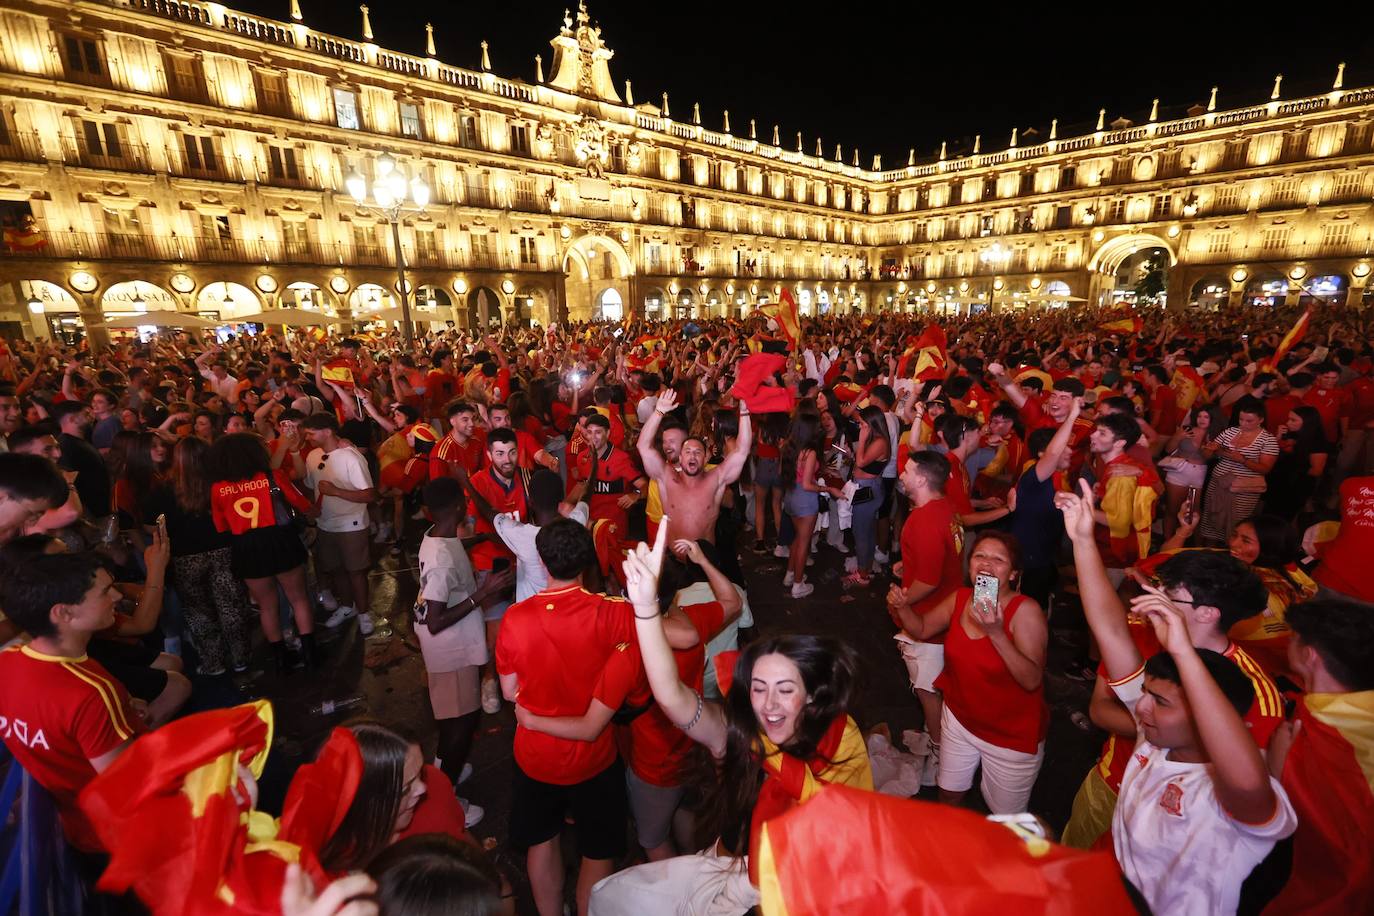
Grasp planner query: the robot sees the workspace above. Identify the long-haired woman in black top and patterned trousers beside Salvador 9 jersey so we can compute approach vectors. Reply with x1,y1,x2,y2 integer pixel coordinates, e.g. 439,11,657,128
143,435,253,677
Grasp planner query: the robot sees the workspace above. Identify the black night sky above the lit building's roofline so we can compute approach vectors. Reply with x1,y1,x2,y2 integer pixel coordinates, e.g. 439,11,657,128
227,0,1374,168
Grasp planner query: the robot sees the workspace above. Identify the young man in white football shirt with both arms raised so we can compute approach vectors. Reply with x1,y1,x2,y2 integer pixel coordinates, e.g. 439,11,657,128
1055,483,1297,916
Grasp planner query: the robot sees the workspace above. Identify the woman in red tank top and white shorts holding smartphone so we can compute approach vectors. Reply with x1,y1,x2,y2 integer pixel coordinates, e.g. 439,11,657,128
903,530,1050,814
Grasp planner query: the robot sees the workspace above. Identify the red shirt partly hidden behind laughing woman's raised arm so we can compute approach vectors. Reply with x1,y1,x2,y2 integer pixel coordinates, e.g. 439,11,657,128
610,602,725,787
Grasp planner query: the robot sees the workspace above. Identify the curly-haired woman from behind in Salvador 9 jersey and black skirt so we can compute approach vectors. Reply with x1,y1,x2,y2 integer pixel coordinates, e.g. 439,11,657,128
207,433,317,670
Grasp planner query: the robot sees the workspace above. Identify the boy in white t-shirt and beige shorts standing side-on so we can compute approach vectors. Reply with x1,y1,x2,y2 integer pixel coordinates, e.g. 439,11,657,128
414,477,514,827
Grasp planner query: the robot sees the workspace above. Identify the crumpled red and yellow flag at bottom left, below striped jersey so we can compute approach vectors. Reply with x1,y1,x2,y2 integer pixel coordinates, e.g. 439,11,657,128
78,700,298,916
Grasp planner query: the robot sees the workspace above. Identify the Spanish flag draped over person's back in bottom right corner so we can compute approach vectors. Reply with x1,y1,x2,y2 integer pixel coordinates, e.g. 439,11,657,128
1264,691,1374,916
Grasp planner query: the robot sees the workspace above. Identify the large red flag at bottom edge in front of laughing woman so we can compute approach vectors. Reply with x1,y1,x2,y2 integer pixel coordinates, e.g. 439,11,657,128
757,786,1136,916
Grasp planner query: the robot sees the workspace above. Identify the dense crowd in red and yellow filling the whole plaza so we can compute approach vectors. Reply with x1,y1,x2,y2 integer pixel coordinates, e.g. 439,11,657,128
0,299,1374,916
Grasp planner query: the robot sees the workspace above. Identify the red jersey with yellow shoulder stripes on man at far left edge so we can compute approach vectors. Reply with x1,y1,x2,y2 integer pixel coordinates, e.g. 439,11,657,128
0,645,143,851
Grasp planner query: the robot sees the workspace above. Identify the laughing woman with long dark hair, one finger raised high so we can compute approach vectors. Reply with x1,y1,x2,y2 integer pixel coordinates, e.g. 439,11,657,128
592,522,872,916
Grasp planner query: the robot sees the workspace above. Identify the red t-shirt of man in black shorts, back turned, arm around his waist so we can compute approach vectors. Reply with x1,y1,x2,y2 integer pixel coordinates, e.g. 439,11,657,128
496,585,638,786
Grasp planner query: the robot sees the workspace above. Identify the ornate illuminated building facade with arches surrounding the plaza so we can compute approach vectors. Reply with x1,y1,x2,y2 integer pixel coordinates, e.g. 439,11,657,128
0,0,1374,343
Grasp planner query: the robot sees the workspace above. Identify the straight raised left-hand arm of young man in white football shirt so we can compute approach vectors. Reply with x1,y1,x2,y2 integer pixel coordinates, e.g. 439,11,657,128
1054,481,1145,681
